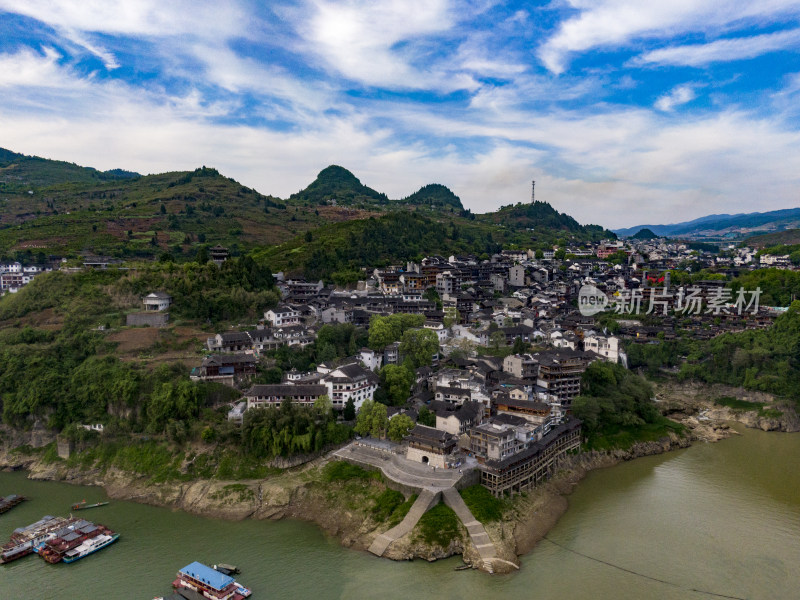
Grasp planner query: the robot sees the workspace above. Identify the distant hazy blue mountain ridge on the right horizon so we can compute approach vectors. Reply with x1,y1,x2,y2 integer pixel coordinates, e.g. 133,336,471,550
614,208,800,239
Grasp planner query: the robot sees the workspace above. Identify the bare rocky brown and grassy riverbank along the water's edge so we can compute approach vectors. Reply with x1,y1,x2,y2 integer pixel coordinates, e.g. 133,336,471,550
0,384,800,572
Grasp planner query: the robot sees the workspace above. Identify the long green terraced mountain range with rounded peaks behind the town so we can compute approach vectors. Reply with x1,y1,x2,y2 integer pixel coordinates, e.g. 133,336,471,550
0,150,613,270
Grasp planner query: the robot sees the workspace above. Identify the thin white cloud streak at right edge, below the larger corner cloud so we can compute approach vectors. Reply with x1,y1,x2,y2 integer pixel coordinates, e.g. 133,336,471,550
631,29,800,67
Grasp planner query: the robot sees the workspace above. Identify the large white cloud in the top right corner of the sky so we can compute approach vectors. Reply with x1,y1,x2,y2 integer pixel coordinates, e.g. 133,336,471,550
537,0,800,74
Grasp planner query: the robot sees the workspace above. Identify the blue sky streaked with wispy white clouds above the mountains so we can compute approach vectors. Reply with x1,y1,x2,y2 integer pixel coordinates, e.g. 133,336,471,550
0,0,800,228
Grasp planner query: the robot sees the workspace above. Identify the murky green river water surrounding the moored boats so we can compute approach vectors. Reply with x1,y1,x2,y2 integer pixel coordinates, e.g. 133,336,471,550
0,430,800,600
